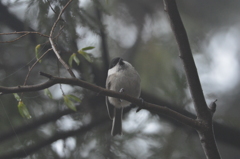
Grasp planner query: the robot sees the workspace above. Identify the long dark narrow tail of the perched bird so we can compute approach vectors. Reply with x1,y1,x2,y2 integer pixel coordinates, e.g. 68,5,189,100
111,108,123,136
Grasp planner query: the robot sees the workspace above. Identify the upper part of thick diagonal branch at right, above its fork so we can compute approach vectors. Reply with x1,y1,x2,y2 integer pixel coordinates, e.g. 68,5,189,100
164,0,209,118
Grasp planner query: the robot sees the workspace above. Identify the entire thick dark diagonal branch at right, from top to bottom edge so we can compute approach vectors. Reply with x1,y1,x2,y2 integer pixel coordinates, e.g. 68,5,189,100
164,0,221,159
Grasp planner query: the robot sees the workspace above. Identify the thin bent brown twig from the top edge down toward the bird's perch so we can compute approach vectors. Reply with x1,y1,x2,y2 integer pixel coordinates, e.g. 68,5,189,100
49,0,76,78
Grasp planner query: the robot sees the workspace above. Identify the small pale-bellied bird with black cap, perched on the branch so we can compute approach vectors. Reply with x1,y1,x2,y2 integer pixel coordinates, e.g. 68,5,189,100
106,57,141,136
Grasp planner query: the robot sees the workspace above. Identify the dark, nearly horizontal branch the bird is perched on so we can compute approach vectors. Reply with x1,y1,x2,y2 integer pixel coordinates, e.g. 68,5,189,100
0,72,201,129
